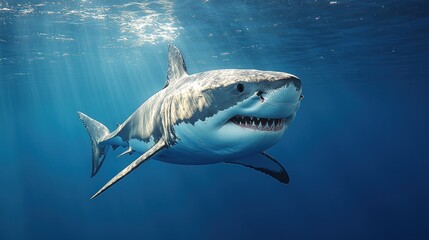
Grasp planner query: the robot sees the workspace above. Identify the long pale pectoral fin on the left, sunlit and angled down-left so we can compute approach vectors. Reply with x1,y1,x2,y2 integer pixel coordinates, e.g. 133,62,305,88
91,139,166,199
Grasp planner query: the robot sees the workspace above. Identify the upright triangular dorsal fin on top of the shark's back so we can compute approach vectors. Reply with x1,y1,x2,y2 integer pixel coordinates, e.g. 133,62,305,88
164,45,188,88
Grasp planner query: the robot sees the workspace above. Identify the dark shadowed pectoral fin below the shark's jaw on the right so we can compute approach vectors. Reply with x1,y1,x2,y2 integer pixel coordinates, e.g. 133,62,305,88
227,152,289,184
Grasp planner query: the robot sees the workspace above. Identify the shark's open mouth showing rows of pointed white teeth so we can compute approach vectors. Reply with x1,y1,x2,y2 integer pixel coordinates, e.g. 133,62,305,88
229,116,286,132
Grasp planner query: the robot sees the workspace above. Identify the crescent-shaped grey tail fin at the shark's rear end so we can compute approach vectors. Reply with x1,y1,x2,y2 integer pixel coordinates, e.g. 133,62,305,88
77,112,109,177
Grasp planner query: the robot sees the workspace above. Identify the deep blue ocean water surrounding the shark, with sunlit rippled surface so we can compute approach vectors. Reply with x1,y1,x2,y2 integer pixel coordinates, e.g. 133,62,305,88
0,0,429,239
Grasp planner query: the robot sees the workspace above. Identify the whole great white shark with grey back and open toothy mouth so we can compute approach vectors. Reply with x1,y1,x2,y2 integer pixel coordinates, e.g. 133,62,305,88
78,45,303,199
